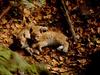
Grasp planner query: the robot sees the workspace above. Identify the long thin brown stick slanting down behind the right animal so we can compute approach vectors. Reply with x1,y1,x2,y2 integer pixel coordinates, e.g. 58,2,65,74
61,0,77,41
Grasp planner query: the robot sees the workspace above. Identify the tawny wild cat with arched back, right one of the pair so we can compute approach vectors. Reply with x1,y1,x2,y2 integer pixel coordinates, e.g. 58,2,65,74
32,31,69,52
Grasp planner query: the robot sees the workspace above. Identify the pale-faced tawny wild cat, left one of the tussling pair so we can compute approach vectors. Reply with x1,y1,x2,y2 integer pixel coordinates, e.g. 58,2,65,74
13,26,48,55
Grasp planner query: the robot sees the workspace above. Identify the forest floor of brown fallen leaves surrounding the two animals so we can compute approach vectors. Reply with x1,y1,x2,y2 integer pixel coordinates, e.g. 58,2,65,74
0,0,100,75
